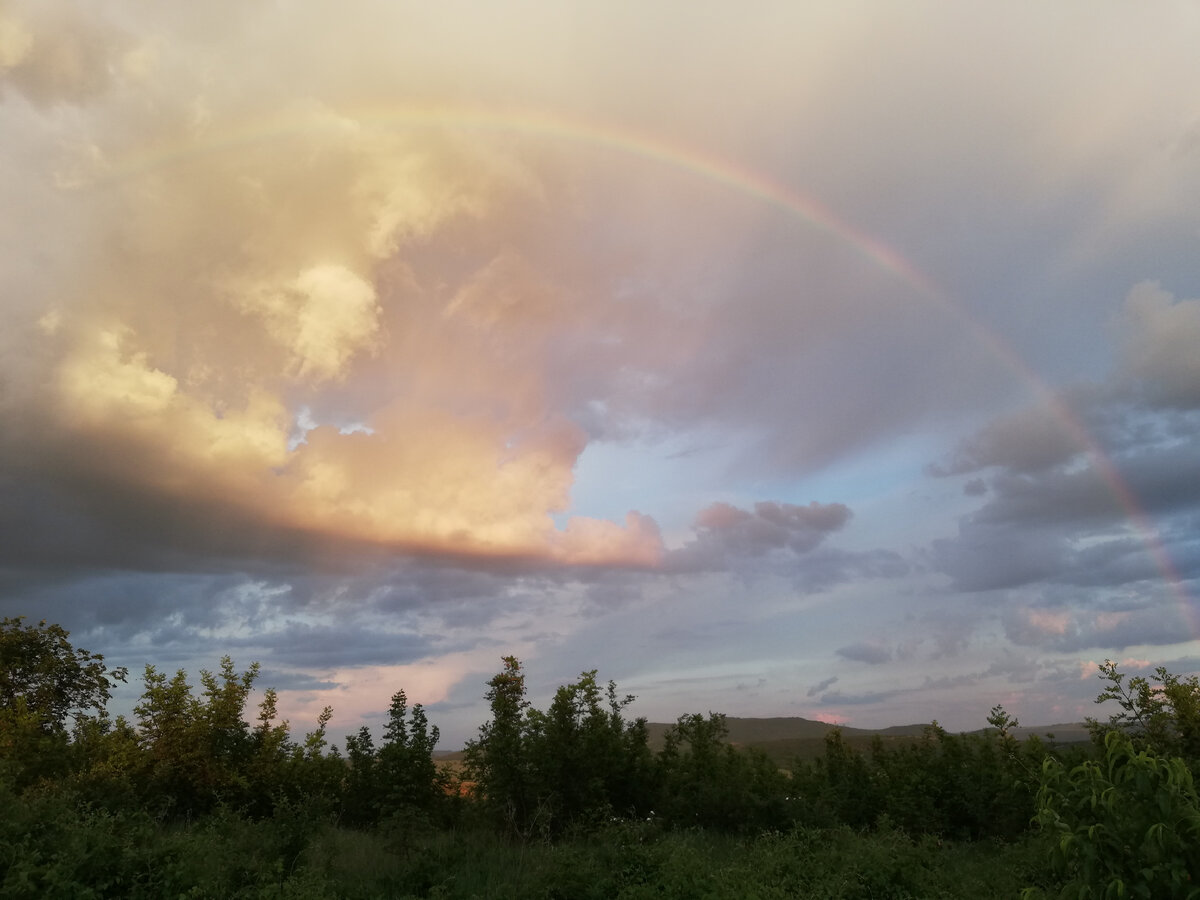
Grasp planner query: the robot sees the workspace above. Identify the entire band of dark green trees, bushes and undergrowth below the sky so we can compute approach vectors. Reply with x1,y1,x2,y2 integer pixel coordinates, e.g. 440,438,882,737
0,618,1200,898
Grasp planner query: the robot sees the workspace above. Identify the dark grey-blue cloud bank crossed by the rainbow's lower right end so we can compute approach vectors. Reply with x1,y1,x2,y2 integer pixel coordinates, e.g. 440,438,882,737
926,328,1200,600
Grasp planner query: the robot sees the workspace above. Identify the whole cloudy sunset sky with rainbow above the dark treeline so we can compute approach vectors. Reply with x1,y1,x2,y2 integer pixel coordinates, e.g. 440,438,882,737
0,0,1200,749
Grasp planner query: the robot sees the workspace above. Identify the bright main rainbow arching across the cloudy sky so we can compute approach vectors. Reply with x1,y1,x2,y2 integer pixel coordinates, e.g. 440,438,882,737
90,103,1200,619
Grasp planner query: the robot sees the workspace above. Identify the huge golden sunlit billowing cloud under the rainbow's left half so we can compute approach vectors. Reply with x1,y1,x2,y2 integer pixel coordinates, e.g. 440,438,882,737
0,42,661,565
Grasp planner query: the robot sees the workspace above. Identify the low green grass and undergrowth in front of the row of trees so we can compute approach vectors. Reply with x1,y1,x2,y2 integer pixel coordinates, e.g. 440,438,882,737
0,791,1044,900
